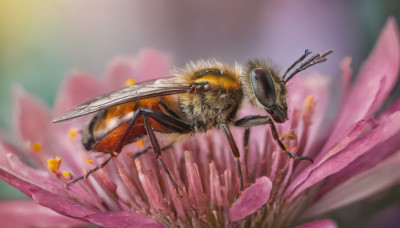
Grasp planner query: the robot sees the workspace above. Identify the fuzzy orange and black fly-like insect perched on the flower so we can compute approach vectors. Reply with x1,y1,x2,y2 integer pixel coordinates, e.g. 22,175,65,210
53,50,333,195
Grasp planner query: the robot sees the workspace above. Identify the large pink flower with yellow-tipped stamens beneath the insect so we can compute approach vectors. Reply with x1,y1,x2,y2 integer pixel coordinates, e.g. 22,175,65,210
0,18,400,227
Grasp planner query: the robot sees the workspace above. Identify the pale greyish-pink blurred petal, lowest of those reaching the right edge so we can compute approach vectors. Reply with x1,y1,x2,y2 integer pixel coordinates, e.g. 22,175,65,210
303,150,400,218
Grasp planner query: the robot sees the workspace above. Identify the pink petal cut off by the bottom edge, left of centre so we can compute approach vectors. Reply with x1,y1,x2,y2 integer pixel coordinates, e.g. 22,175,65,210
84,211,164,228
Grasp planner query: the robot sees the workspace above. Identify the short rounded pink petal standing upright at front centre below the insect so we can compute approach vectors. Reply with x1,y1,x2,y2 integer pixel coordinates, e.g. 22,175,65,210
229,176,272,221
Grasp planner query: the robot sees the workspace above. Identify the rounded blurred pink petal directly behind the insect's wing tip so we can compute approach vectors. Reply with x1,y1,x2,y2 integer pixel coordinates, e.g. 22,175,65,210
54,71,107,115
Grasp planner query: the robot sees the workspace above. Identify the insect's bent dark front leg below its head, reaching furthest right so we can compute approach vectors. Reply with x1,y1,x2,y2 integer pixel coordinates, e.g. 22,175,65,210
234,115,314,163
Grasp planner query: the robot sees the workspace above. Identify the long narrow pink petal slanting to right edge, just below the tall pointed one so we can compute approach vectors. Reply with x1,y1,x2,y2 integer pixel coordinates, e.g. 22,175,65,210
286,112,400,199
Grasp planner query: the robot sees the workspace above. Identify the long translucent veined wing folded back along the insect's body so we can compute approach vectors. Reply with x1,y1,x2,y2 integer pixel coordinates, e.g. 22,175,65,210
53,77,192,123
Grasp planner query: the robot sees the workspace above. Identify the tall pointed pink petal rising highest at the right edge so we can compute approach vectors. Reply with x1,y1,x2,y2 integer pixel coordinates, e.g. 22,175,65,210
325,18,400,148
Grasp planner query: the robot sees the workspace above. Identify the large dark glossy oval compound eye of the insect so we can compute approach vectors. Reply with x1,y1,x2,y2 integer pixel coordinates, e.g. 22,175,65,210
250,69,276,108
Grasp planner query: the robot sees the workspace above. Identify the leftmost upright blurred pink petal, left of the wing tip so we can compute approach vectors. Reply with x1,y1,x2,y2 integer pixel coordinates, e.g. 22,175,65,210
13,87,50,143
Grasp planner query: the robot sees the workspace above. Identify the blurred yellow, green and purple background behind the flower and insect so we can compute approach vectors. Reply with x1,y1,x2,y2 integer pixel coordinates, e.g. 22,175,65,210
0,0,400,227
